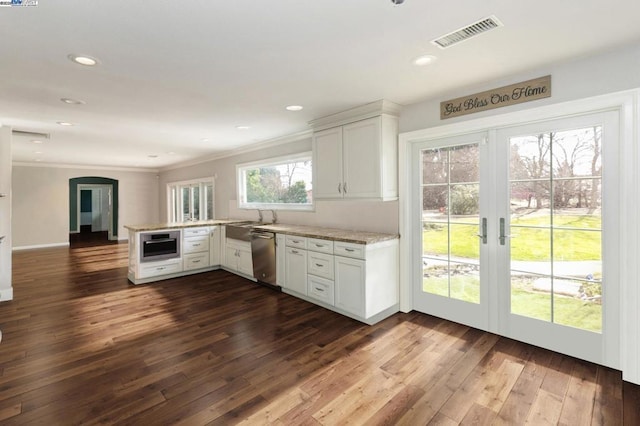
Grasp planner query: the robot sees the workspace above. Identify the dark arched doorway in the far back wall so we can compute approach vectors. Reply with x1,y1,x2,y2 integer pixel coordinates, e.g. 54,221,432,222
69,176,118,245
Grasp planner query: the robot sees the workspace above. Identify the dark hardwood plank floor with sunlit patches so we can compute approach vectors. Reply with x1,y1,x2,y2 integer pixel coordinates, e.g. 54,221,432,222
0,244,640,425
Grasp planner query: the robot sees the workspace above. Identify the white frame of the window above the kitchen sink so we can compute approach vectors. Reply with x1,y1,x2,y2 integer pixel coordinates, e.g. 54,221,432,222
236,151,315,211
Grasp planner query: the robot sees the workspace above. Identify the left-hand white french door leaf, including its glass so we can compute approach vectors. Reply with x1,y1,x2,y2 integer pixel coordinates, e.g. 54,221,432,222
412,133,491,330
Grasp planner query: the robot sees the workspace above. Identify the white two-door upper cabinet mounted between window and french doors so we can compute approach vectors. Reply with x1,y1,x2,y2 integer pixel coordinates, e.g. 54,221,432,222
312,100,398,200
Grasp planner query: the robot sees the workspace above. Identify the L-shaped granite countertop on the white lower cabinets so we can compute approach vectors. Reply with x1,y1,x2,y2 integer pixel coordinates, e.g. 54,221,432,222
125,219,399,244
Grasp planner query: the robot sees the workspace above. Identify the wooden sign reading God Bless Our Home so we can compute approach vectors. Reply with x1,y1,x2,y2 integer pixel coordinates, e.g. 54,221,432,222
440,75,551,120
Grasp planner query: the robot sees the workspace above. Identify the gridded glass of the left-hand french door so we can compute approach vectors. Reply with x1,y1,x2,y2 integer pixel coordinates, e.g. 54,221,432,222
421,144,480,303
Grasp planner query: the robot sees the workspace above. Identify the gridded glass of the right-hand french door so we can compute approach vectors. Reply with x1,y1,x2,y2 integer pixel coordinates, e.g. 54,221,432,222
509,126,602,332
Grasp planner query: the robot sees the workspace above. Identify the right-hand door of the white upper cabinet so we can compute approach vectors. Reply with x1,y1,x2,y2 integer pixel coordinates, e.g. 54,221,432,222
344,117,382,198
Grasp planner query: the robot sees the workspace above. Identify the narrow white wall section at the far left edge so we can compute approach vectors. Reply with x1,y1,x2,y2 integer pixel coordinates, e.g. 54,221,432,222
0,126,13,301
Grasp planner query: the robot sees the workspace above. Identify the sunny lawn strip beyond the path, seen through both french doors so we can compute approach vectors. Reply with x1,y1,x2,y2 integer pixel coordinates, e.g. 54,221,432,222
422,215,602,261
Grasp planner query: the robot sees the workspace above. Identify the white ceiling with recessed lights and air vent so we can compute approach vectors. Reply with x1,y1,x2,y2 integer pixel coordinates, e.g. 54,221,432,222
0,0,640,169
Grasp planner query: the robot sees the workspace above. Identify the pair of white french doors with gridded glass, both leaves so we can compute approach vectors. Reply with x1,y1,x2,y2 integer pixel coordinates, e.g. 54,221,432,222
412,112,620,367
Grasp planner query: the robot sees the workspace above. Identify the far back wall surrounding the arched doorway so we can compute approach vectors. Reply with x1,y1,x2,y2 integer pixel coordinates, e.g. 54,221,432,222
12,165,160,248
